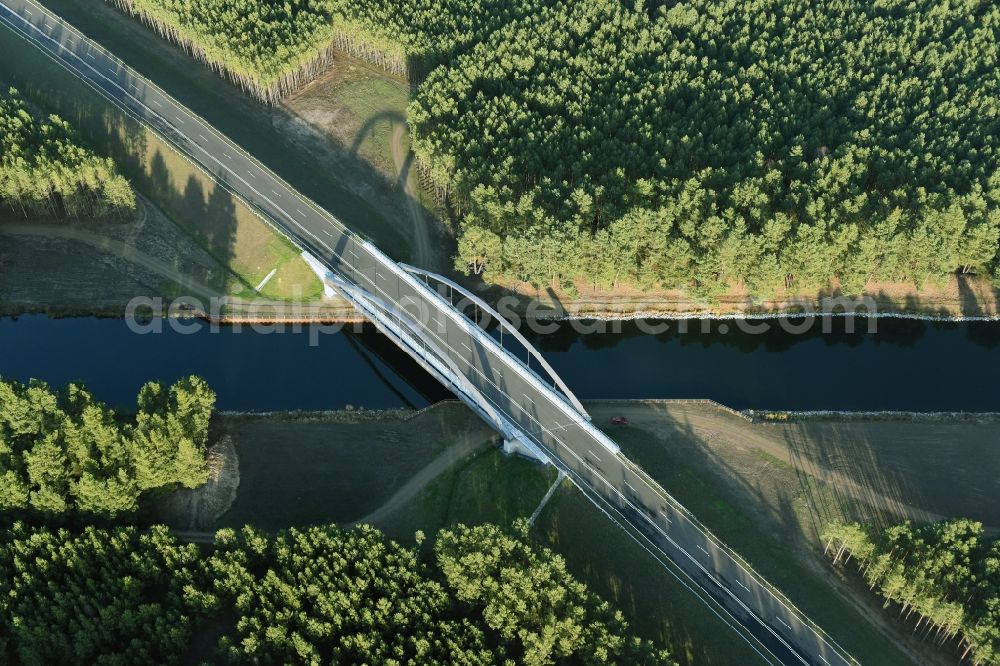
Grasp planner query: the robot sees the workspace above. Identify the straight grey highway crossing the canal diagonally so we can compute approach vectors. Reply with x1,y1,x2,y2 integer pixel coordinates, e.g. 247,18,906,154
0,0,858,666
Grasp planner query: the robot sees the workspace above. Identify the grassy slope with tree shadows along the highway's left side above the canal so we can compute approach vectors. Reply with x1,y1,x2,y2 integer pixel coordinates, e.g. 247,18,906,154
0,18,321,311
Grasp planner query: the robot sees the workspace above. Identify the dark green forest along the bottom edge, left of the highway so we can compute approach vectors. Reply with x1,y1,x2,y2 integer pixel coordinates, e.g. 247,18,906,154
0,524,670,666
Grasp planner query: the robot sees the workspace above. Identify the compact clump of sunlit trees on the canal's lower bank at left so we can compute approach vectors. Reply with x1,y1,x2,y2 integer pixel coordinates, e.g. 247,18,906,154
0,377,215,519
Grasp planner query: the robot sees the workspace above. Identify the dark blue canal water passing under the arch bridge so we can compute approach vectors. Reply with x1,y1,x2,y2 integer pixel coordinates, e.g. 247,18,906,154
0,316,1000,411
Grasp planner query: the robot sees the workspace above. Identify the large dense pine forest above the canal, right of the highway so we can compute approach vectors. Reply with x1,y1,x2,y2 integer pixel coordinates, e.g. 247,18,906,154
409,0,1000,296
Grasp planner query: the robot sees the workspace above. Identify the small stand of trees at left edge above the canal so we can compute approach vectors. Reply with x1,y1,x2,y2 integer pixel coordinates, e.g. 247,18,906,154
0,88,136,217
